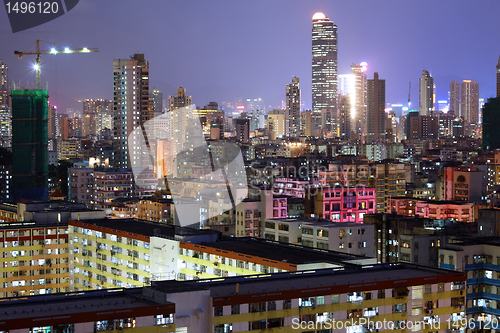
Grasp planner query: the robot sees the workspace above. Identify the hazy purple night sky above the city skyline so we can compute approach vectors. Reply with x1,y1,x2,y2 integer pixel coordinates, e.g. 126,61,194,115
0,0,500,110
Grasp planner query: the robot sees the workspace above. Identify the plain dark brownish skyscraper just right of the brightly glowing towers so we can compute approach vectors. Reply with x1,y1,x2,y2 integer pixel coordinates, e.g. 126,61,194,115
366,72,385,143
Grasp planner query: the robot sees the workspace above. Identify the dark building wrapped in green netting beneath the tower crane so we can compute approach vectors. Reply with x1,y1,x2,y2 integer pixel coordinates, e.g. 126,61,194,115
11,90,49,200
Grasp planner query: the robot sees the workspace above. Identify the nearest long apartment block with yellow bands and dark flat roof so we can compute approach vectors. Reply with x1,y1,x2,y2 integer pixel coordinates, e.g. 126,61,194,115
0,264,465,333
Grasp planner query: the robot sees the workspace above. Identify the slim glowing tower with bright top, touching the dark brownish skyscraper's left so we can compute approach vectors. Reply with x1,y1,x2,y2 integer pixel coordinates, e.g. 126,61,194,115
350,62,367,139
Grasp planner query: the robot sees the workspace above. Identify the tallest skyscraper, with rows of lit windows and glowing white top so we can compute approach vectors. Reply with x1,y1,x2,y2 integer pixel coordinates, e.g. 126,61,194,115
312,13,337,133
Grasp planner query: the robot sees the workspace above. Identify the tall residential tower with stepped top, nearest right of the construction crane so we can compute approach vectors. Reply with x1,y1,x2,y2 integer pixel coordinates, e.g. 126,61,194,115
113,54,152,168
